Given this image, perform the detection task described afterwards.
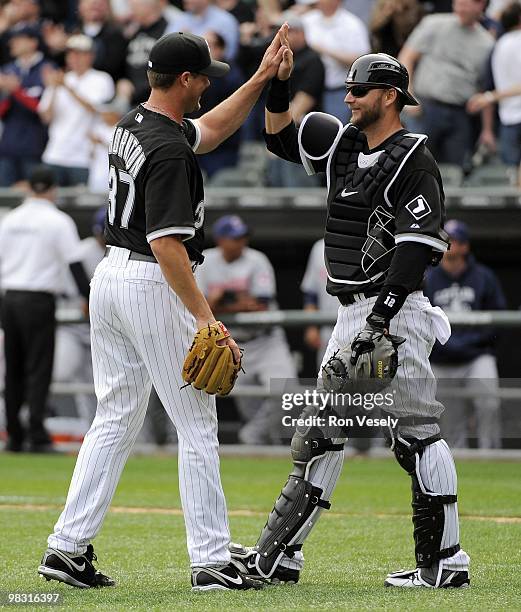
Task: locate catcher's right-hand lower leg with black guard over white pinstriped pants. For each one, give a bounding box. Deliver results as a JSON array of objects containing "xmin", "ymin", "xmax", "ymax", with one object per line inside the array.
[{"xmin": 394, "ymin": 435, "xmax": 468, "ymax": 569}]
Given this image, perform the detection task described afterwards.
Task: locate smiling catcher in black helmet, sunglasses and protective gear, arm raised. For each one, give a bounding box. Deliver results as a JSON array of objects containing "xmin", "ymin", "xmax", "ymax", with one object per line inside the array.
[{"xmin": 233, "ymin": 43, "xmax": 469, "ymax": 588}]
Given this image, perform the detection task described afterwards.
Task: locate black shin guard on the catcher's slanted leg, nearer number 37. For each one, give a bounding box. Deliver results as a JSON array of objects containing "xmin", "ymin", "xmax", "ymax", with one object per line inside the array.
[{"xmin": 254, "ymin": 407, "xmax": 344, "ymax": 578}]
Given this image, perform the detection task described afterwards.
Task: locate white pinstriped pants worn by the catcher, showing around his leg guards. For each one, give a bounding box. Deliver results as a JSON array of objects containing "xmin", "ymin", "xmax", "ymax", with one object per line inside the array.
[{"xmin": 281, "ymin": 291, "xmax": 469, "ymax": 570}]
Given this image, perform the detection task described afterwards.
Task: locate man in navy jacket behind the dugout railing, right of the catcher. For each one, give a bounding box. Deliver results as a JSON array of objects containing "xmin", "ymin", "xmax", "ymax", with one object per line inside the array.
[{"xmin": 424, "ymin": 220, "xmax": 505, "ymax": 448}]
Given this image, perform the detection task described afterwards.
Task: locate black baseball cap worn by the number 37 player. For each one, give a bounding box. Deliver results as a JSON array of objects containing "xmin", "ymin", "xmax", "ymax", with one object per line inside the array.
[{"xmin": 148, "ymin": 32, "xmax": 230, "ymax": 77}]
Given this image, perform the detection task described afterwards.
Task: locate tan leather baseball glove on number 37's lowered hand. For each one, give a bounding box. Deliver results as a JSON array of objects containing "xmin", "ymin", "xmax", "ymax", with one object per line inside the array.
[{"xmin": 183, "ymin": 321, "xmax": 241, "ymax": 395}]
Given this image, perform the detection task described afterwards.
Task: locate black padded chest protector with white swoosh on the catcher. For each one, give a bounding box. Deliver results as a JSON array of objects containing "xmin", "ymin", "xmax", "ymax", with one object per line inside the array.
[{"xmin": 324, "ymin": 125, "xmax": 425, "ymax": 294}]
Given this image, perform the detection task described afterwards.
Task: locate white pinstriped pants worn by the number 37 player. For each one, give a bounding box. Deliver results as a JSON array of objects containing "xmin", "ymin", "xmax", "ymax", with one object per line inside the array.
[{"xmin": 48, "ymin": 247, "xmax": 230, "ymax": 566}]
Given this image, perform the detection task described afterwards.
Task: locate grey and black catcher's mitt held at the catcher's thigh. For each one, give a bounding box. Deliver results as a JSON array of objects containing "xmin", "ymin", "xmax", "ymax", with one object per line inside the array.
[{"xmin": 322, "ymin": 327, "xmax": 405, "ymax": 393}]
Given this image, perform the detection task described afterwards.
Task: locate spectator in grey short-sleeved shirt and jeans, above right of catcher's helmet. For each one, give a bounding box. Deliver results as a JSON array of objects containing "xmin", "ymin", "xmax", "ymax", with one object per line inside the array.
[{"xmin": 398, "ymin": 0, "xmax": 495, "ymax": 166}]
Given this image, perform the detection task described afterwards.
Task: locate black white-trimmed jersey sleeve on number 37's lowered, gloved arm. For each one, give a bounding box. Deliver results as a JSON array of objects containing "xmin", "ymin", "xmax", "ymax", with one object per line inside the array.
[{"xmin": 145, "ymin": 158, "xmax": 195, "ymax": 243}]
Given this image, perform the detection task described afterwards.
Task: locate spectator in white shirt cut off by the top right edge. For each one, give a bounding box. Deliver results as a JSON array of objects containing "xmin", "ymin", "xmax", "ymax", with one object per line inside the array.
[{"xmin": 468, "ymin": 2, "xmax": 521, "ymax": 166}]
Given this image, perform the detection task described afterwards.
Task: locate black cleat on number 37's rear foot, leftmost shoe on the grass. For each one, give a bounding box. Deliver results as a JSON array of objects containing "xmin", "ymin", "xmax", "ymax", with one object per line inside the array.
[{"xmin": 38, "ymin": 544, "xmax": 116, "ymax": 589}]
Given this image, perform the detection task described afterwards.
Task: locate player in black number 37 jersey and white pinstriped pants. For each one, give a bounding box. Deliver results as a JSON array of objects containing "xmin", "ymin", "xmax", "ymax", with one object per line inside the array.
[{"xmin": 38, "ymin": 25, "xmax": 289, "ymax": 591}]
